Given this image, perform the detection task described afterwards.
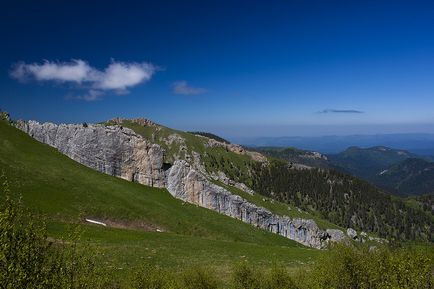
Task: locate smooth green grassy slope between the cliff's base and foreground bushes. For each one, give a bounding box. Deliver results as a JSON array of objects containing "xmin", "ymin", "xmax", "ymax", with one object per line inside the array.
[{"xmin": 0, "ymin": 122, "xmax": 320, "ymax": 282}]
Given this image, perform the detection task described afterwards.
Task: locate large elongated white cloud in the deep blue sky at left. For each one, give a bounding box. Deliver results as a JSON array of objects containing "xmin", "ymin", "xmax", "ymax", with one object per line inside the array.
[{"xmin": 10, "ymin": 59, "xmax": 158, "ymax": 101}]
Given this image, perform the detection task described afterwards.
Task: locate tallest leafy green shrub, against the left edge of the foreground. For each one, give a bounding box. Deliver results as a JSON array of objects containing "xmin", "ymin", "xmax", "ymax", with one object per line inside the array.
[{"xmin": 0, "ymin": 180, "xmax": 59, "ymax": 288}]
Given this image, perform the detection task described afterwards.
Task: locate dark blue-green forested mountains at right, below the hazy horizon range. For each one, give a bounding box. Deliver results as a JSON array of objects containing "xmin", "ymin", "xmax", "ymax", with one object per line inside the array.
[{"xmin": 255, "ymin": 146, "xmax": 434, "ymax": 195}]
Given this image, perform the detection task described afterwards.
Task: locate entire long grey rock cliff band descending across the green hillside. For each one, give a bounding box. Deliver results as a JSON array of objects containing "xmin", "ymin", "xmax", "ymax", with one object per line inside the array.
[{"xmin": 15, "ymin": 121, "xmax": 344, "ymax": 248}]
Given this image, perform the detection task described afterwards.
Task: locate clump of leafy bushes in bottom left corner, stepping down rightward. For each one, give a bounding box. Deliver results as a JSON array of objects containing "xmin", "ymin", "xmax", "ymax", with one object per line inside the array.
[{"xmin": 0, "ymin": 177, "xmax": 108, "ymax": 289}]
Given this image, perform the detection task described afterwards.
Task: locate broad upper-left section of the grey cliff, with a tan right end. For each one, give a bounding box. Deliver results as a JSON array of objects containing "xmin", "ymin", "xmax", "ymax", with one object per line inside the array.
[{"xmin": 15, "ymin": 121, "xmax": 166, "ymax": 188}]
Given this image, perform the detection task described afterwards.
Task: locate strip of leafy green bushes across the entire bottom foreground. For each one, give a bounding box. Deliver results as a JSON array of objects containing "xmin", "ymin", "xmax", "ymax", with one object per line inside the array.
[{"xmin": 0, "ymin": 181, "xmax": 434, "ymax": 289}]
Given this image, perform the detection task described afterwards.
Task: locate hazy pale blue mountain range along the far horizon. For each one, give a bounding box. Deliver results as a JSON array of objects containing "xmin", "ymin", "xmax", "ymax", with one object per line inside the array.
[{"xmin": 231, "ymin": 133, "xmax": 434, "ymax": 156}]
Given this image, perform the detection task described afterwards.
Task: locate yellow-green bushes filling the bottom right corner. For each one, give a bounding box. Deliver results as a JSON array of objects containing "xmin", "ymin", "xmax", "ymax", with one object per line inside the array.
[{"xmin": 299, "ymin": 245, "xmax": 434, "ymax": 289}]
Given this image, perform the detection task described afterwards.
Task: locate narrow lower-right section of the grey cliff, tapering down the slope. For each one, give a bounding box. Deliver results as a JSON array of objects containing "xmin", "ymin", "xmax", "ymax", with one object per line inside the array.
[{"xmin": 167, "ymin": 160, "xmax": 344, "ymax": 248}]
